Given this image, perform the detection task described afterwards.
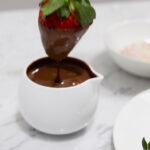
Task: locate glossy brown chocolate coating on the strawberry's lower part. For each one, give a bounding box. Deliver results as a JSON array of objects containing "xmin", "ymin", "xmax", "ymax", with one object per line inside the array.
[{"xmin": 39, "ymin": 21, "xmax": 88, "ymax": 61}]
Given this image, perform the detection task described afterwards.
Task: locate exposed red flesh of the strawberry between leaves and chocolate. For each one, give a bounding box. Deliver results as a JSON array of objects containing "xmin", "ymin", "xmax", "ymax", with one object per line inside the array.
[{"xmin": 39, "ymin": 2, "xmax": 80, "ymax": 29}]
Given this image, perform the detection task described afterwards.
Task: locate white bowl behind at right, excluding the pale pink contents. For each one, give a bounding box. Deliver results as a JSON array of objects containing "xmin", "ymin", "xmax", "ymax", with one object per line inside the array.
[{"xmin": 105, "ymin": 21, "xmax": 150, "ymax": 77}]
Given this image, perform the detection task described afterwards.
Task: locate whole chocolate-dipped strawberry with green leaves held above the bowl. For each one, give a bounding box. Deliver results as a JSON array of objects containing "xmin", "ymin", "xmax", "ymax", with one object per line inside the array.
[{"xmin": 39, "ymin": 0, "xmax": 96, "ymax": 62}]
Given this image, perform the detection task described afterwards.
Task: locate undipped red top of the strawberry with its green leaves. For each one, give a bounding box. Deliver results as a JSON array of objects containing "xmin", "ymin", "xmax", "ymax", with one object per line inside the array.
[{"xmin": 39, "ymin": 0, "xmax": 96, "ymax": 29}]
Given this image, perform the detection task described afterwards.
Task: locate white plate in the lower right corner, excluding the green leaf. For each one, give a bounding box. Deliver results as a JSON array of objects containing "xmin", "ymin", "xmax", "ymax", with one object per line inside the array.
[{"xmin": 113, "ymin": 90, "xmax": 150, "ymax": 150}]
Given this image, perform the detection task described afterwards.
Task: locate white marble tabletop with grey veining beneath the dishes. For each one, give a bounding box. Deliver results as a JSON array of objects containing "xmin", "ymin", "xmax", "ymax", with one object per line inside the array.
[{"xmin": 0, "ymin": 1, "xmax": 150, "ymax": 150}]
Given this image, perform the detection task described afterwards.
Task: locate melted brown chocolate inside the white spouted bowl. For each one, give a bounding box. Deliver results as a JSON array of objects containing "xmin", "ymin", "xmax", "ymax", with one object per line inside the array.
[{"xmin": 27, "ymin": 57, "xmax": 96, "ymax": 88}]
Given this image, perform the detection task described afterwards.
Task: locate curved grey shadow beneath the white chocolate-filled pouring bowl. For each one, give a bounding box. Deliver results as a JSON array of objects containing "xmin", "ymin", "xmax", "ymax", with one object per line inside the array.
[{"xmin": 17, "ymin": 112, "xmax": 87, "ymax": 142}]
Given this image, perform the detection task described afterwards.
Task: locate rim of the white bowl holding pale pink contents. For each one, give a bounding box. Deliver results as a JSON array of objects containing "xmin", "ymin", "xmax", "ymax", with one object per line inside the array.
[{"xmin": 104, "ymin": 19, "xmax": 150, "ymax": 65}]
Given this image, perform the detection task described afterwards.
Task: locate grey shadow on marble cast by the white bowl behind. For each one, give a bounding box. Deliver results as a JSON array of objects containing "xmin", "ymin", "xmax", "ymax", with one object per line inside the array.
[{"xmin": 91, "ymin": 50, "xmax": 150, "ymax": 96}]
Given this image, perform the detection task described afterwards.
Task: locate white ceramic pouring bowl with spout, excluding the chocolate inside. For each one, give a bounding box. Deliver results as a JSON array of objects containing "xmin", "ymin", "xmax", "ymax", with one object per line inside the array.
[{"xmin": 19, "ymin": 57, "xmax": 103, "ymax": 135}]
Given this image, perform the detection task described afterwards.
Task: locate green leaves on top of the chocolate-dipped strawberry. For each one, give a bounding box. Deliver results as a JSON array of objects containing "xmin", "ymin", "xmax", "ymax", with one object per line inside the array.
[{"xmin": 41, "ymin": 0, "xmax": 96, "ymax": 27}]
